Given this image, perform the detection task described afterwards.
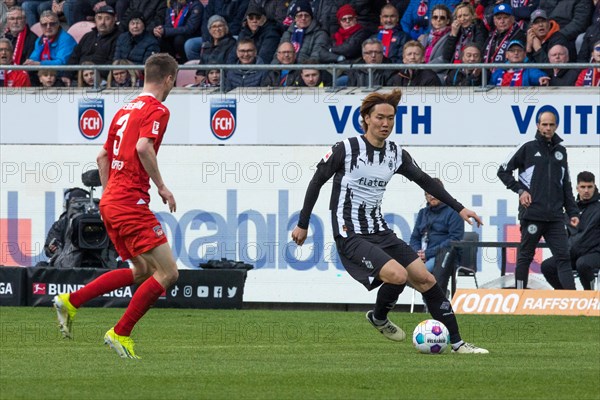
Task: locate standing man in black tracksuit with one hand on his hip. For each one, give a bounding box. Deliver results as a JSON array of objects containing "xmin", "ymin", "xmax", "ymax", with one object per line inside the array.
[{"xmin": 498, "ymin": 111, "xmax": 579, "ymax": 290}]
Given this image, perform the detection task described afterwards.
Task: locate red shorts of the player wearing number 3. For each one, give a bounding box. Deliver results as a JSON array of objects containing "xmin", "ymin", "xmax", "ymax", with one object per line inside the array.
[{"xmin": 100, "ymin": 203, "xmax": 167, "ymax": 260}]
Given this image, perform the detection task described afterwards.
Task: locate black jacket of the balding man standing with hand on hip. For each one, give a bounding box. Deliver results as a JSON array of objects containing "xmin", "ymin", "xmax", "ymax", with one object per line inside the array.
[{"xmin": 498, "ymin": 131, "xmax": 579, "ymax": 221}]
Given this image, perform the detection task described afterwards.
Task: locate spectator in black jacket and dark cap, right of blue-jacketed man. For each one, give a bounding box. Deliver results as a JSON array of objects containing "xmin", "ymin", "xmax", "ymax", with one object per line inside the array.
[{"xmin": 62, "ymin": 6, "xmax": 119, "ymax": 86}]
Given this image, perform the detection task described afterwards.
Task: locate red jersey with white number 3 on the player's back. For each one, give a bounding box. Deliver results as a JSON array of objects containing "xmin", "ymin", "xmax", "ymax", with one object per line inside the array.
[{"xmin": 102, "ymin": 93, "xmax": 171, "ymax": 204}]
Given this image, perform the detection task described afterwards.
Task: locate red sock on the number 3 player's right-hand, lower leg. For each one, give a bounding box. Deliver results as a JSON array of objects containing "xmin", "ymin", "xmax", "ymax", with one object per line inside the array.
[{"xmin": 115, "ymin": 276, "xmax": 165, "ymax": 336}]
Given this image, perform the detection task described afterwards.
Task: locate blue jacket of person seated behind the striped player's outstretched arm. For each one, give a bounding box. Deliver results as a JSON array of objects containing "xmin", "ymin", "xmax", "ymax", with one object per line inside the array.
[{"xmin": 410, "ymin": 203, "xmax": 465, "ymax": 259}]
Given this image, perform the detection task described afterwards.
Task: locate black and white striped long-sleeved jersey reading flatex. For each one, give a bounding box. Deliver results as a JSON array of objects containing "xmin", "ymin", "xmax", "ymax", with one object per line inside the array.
[{"xmin": 298, "ymin": 136, "xmax": 463, "ymax": 237}]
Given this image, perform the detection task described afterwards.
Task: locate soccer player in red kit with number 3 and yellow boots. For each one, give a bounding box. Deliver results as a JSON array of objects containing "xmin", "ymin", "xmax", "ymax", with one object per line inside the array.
[{"xmin": 54, "ymin": 53, "xmax": 178, "ymax": 358}]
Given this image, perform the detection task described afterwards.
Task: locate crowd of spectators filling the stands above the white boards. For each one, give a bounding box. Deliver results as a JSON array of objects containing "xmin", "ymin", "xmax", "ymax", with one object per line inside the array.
[{"xmin": 0, "ymin": 0, "xmax": 600, "ymax": 89}]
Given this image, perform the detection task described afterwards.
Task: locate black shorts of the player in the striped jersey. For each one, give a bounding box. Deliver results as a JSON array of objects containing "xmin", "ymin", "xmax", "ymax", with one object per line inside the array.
[{"xmin": 335, "ymin": 230, "xmax": 419, "ymax": 290}]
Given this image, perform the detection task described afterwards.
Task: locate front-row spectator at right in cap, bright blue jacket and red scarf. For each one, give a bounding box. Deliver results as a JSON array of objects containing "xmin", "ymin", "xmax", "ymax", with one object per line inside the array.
[{"xmin": 491, "ymin": 40, "xmax": 550, "ymax": 86}]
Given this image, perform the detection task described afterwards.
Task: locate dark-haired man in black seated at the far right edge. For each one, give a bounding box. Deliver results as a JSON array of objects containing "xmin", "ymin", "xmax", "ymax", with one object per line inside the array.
[{"xmin": 542, "ymin": 171, "xmax": 600, "ymax": 290}]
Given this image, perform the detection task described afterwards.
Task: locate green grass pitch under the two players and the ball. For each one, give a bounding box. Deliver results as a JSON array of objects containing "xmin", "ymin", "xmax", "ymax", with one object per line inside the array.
[{"xmin": 0, "ymin": 307, "xmax": 600, "ymax": 400}]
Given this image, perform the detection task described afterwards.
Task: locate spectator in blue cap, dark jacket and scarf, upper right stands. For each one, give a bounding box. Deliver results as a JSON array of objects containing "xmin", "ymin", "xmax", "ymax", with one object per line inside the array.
[{"xmin": 482, "ymin": 4, "xmax": 527, "ymax": 63}]
